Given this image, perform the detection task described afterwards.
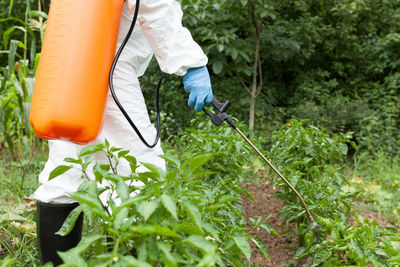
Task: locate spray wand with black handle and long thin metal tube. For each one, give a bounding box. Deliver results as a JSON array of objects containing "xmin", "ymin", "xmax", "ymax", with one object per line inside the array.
[{"xmin": 203, "ymin": 97, "xmax": 314, "ymax": 222}]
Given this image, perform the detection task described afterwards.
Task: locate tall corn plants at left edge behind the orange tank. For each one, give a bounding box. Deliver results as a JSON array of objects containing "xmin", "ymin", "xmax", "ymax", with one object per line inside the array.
[{"xmin": 0, "ymin": 1, "xmax": 46, "ymax": 189}]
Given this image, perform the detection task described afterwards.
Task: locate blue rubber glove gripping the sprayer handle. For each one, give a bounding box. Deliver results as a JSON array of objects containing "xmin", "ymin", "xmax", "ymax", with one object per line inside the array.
[{"xmin": 183, "ymin": 66, "xmax": 213, "ymax": 112}]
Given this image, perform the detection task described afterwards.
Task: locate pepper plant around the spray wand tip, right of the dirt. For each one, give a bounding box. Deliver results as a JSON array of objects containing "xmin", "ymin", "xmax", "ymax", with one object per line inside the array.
[{"xmin": 270, "ymin": 120, "xmax": 354, "ymax": 222}]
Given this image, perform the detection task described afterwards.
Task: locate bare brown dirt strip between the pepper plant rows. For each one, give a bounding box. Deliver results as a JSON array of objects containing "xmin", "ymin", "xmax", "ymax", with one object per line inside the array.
[{"xmin": 242, "ymin": 184, "xmax": 297, "ymax": 267}]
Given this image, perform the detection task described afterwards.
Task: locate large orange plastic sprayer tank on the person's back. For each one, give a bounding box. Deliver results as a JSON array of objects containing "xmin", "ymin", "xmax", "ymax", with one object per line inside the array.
[{"xmin": 30, "ymin": 0, "xmax": 124, "ymax": 144}]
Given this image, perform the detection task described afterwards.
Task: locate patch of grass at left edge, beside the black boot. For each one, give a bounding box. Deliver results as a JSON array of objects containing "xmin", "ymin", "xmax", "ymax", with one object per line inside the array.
[{"xmin": 0, "ymin": 149, "xmax": 47, "ymax": 266}]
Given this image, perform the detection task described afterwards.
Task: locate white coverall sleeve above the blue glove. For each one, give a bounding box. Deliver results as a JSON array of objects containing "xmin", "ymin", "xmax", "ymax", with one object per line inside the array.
[{"xmin": 129, "ymin": 0, "xmax": 208, "ymax": 76}]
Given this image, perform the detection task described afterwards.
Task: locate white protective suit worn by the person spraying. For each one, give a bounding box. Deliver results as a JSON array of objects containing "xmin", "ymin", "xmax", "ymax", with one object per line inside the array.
[{"xmin": 34, "ymin": 0, "xmax": 207, "ymax": 204}]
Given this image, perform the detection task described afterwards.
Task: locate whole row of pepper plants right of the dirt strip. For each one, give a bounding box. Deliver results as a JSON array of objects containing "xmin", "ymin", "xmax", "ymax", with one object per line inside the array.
[{"xmin": 271, "ymin": 120, "xmax": 400, "ymax": 266}]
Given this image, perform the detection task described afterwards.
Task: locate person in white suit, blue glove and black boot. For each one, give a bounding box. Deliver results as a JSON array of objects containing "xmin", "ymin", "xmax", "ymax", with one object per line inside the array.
[{"xmin": 34, "ymin": 0, "xmax": 212, "ymax": 264}]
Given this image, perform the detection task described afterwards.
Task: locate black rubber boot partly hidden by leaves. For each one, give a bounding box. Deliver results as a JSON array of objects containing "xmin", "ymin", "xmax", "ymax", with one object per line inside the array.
[{"xmin": 37, "ymin": 201, "xmax": 83, "ymax": 266}]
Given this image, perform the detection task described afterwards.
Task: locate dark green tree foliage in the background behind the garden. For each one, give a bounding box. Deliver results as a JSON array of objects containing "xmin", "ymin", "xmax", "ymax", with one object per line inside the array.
[{"xmin": 147, "ymin": 0, "xmax": 400, "ymax": 154}]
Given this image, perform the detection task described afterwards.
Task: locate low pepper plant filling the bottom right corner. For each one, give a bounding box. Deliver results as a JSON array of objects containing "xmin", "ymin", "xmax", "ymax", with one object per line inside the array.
[{"xmin": 295, "ymin": 217, "xmax": 400, "ymax": 267}]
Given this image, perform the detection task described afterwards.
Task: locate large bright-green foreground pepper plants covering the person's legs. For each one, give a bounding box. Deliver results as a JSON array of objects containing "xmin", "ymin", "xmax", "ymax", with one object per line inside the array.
[{"xmin": 50, "ymin": 141, "xmax": 268, "ymax": 266}]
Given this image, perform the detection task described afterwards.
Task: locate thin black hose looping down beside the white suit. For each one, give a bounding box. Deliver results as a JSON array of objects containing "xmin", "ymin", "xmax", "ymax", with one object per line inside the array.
[{"xmin": 108, "ymin": 0, "xmax": 166, "ymax": 148}]
